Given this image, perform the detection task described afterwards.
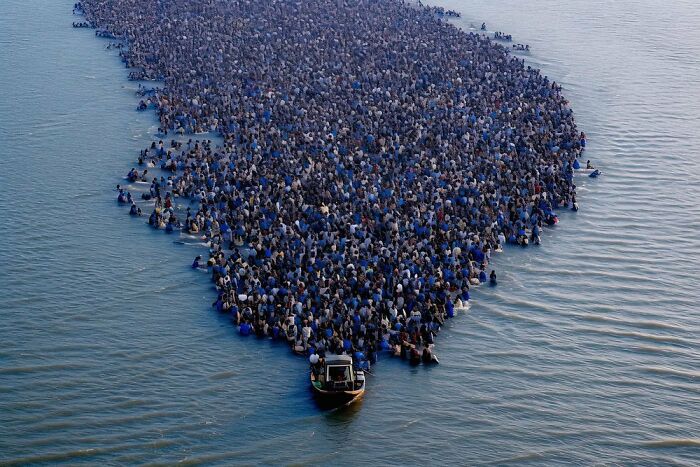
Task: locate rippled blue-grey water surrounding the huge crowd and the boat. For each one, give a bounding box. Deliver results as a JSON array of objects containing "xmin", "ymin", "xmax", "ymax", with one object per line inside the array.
[{"xmin": 0, "ymin": 0, "xmax": 700, "ymax": 465}]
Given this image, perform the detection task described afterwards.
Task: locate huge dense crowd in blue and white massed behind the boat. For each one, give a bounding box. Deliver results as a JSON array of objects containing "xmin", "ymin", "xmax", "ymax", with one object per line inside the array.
[{"xmin": 79, "ymin": 0, "xmax": 585, "ymax": 368}]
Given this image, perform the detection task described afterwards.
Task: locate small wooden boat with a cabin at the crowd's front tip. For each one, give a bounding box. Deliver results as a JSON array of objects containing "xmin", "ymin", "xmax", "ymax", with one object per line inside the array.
[{"xmin": 310, "ymin": 355, "xmax": 365, "ymax": 407}]
